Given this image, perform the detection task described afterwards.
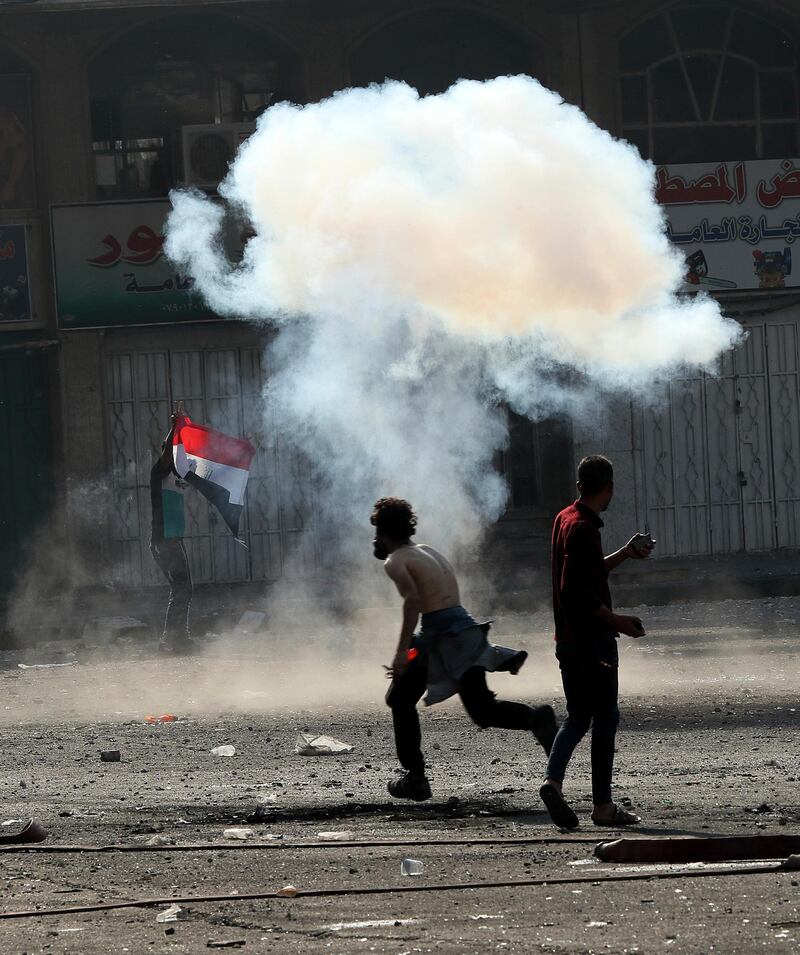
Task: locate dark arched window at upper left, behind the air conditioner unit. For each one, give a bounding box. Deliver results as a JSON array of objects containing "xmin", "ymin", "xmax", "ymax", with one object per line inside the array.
[{"xmin": 89, "ymin": 14, "xmax": 296, "ymax": 199}]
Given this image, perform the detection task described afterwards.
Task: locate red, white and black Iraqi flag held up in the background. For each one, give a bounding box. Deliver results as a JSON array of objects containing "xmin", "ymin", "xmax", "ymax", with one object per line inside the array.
[{"xmin": 172, "ymin": 415, "xmax": 256, "ymax": 540}]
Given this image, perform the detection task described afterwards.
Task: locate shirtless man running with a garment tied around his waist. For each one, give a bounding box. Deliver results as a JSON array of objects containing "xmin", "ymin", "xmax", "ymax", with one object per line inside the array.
[{"xmin": 370, "ymin": 497, "xmax": 557, "ymax": 802}]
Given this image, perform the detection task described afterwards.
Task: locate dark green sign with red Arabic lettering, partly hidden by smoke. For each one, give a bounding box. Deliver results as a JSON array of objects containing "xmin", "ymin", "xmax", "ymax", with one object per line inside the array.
[{"xmin": 52, "ymin": 200, "xmax": 217, "ymax": 328}]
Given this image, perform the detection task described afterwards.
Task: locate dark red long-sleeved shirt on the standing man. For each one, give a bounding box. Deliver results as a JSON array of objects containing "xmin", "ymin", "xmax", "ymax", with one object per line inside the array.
[{"xmin": 552, "ymin": 501, "xmax": 618, "ymax": 641}]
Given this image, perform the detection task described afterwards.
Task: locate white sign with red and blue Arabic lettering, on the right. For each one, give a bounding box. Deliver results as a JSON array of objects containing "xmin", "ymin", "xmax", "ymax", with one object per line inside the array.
[{"xmin": 656, "ymin": 159, "xmax": 800, "ymax": 291}]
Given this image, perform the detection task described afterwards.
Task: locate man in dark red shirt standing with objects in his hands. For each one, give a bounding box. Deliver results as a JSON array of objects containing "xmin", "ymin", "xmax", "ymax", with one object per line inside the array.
[{"xmin": 539, "ymin": 455, "xmax": 655, "ymax": 829}]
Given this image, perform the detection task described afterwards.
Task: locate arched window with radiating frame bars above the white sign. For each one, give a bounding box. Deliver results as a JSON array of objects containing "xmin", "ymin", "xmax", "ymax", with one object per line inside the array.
[{"xmin": 619, "ymin": 3, "xmax": 798, "ymax": 163}]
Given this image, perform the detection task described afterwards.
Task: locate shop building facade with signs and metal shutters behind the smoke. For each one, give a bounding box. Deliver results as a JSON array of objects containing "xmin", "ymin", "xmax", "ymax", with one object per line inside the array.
[{"xmin": 0, "ymin": 0, "xmax": 800, "ymax": 589}]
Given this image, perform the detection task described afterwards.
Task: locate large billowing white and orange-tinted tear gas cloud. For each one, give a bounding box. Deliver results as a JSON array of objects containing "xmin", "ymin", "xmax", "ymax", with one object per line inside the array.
[{"xmin": 166, "ymin": 77, "xmax": 739, "ymax": 542}]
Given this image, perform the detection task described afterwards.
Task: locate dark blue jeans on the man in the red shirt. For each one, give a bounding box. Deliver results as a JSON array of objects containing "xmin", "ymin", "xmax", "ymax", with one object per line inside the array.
[{"xmin": 547, "ymin": 637, "xmax": 619, "ymax": 806}]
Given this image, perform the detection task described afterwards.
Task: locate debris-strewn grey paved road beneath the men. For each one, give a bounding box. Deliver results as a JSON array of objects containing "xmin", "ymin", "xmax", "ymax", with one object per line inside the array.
[{"xmin": 0, "ymin": 598, "xmax": 800, "ymax": 955}]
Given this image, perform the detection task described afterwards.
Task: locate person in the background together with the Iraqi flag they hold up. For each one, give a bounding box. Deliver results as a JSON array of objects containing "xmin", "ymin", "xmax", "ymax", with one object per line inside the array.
[{"xmin": 150, "ymin": 402, "xmax": 255, "ymax": 654}]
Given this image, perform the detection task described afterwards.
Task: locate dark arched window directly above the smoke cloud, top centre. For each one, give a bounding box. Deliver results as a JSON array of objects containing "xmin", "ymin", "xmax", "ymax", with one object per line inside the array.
[{"xmin": 350, "ymin": 8, "xmax": 534, "ymax": 96}]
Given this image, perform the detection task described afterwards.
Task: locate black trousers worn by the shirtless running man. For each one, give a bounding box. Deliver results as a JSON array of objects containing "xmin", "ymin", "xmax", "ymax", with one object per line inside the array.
[{"xmin": 386, "ymin": 655, "xmax": 536, "ymax": 776}]
